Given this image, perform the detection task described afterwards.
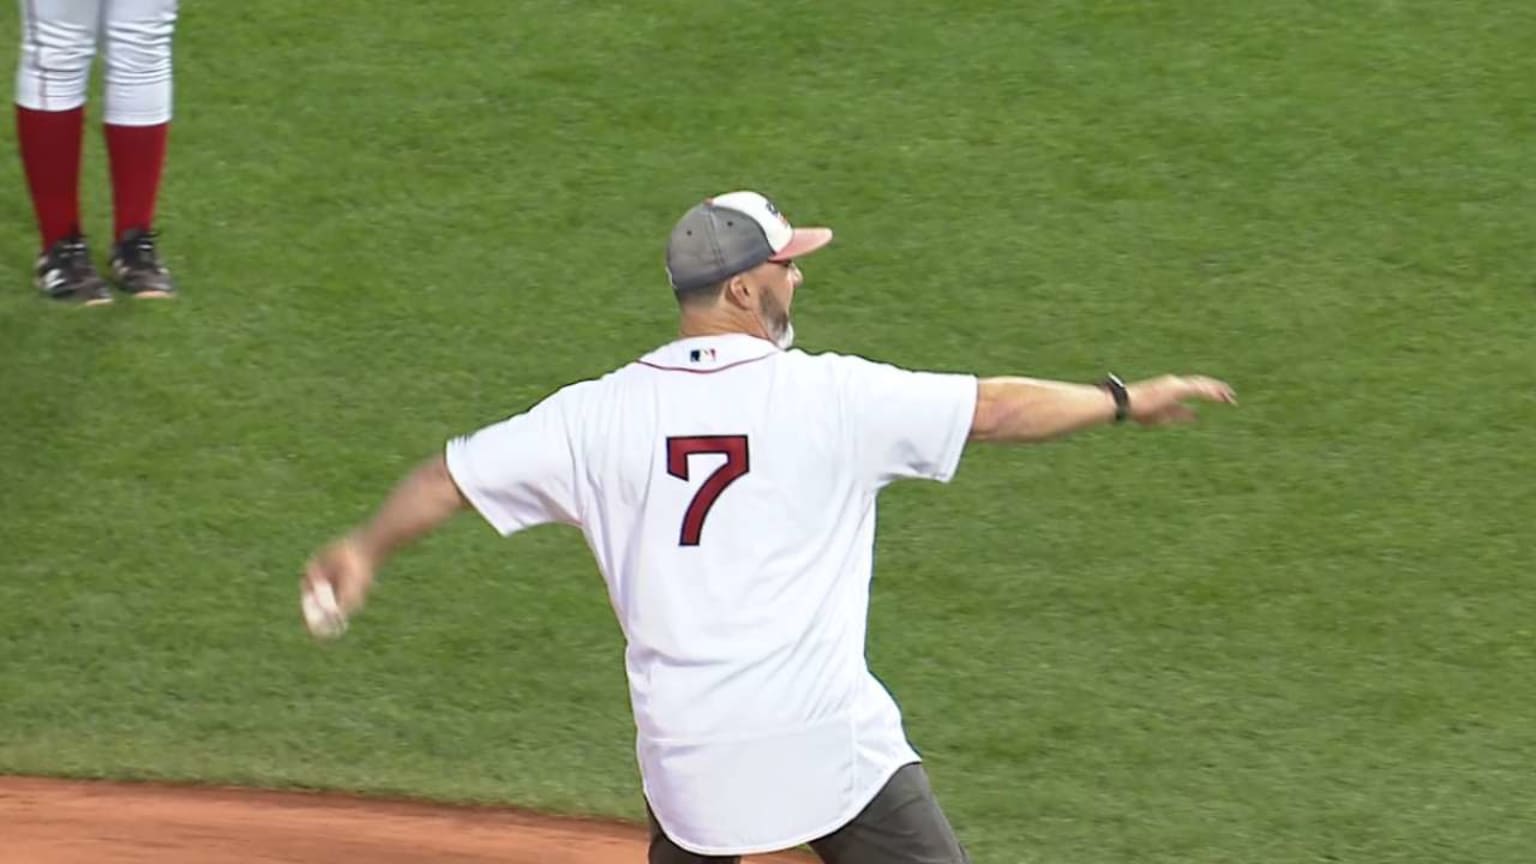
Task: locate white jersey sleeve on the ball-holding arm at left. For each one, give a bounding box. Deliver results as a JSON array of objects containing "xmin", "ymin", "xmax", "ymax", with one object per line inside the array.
[{"xmin": 445, "ymin": 382, "xmax": 581, "ymax": 537}]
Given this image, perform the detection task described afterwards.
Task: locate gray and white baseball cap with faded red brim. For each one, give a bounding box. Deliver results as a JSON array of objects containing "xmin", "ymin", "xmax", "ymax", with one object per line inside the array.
[{"xmin": 667, "ymin": 192, "xmax": 833, "ymax": 291}]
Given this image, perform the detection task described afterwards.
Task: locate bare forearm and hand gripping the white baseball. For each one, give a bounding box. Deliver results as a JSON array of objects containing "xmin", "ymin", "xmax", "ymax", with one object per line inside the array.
[{"xmin": 304, "ymin": 455, "xmax": 465, "ymax": 615}]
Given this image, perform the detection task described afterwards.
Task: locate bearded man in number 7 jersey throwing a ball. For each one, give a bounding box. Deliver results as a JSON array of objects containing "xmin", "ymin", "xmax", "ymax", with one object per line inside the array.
[{"xmin": 304, "ymin": 192, "xmax": 1235, "ymax": 864}]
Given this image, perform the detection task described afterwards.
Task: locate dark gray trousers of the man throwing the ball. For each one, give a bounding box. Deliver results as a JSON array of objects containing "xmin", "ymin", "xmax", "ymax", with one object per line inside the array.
[{"xmin": 647, "ymin": 763, "xmax": 971, "ymax": 864}]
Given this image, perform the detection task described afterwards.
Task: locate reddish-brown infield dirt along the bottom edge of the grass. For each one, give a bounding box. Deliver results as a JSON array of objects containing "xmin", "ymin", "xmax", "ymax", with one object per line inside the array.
[{"xmin": 0, "ymin": 778, "xmax": 811, "ymax": 864}]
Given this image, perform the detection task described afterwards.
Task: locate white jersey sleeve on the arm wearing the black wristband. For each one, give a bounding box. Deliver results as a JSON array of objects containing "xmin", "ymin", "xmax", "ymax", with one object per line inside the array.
[{"xmin": 845, "ymin": 358, "xmax": 977, "ymax": 487}]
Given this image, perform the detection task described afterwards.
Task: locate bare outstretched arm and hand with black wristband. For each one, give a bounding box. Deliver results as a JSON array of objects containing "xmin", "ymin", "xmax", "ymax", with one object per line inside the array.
[{"xmin": 971, "ymin": 375, "xmax": 1236, "ymax": 444}]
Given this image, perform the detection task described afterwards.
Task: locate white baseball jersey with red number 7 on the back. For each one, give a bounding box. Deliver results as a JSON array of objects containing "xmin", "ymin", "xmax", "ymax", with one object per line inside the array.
[{"xmin": 447, "ymin": 335, "xmax": 977, "ymax": 855}]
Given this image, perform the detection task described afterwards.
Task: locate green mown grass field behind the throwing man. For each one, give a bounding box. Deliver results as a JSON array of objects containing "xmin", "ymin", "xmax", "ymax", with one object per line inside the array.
[{"xmin": 0, "ymin": 0, "xmax": 1536, "ymax": 864}]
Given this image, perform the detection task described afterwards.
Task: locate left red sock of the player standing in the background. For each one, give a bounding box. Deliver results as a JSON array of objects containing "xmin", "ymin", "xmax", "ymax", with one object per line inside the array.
[{"xmin": 15, "ymin": 105, "xmax": 86, "ymax": 251}]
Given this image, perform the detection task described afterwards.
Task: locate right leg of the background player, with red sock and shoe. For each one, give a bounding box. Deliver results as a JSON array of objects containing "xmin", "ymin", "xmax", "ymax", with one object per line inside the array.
[{"xmin": 101, "ymin": 0, "xmax": 178, "ymax": 298}]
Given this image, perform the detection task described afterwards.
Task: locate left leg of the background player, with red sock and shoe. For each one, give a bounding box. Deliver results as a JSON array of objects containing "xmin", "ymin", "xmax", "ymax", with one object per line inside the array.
[{"xmin": 15, "ymin": 0, "xmax": 112, "ymax": 306}]
